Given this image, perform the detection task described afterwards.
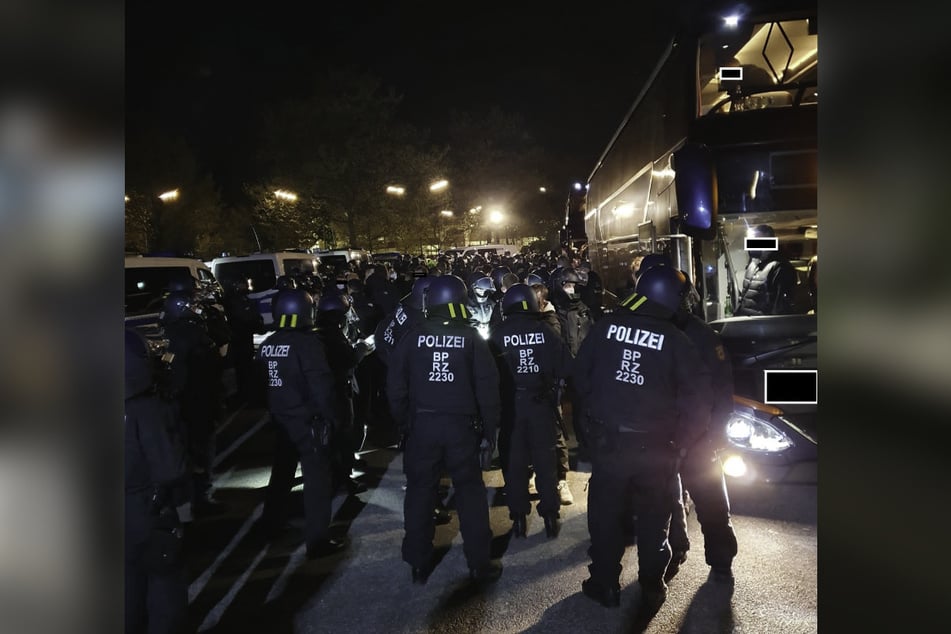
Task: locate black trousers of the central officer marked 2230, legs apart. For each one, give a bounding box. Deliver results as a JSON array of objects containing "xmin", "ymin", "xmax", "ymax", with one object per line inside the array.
[{"xmin": 402, "ymin": 414, "xmax": 492, "ymax": 568}]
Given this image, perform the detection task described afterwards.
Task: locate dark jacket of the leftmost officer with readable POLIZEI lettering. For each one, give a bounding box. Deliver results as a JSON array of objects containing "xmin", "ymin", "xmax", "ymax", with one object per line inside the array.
[{"xmin": 258, "ymin": 328, "xmax": 336, "ymax": 444}]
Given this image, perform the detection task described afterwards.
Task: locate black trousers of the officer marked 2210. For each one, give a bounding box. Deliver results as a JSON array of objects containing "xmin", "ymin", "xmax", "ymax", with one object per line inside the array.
[{"xmin": 502, "ymin": 391, "xmax": 561, "ymax": 519}]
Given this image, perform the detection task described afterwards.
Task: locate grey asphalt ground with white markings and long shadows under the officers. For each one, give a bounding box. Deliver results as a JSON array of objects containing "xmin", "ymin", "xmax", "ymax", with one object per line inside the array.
[{"xmin": 180, "ymin": 400, "xmax": 817, "ymax": 634}]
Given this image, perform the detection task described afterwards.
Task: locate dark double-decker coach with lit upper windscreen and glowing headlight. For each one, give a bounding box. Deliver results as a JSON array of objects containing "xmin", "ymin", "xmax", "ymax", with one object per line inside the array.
[{"xmin": 563, "ymin": 0, "xmax": 819, "ymax": 481}]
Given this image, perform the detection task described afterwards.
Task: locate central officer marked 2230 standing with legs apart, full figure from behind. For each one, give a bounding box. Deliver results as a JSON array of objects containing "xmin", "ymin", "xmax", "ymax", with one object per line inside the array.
[{"xmin": 387, "ymin": 275, "xmax": 501, "ymax": 583}]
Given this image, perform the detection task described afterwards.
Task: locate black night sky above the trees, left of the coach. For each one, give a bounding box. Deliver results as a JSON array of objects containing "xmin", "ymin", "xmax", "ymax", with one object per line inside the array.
[{"xmin": 126, "ymin": 0, "xmax": 669, "ymax": 200}]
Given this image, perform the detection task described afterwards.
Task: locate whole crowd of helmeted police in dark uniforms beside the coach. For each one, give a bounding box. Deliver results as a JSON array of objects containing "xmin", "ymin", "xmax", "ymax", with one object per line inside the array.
[{"xmin": 126, "ymin": 248, "xmax": 737, "ymax": 631}]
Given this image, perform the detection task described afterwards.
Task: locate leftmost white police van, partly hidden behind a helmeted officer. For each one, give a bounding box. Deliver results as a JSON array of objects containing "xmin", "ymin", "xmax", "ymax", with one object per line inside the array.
[{"xmin": 125, "ymin": 255, "xmax": 222, "ymax": 336}]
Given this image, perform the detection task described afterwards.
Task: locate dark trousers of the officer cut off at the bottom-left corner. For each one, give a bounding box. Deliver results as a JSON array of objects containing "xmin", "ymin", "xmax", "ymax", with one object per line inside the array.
[{"xmin": 125, "ymin": 492, "xmax": 188, "ymax": 634}]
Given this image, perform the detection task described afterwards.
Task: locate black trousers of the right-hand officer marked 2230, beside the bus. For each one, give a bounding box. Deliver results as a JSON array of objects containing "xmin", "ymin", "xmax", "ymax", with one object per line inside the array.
[{"xmin": 588, "ymin": 433, "xmax": 676, "ymax": 591}]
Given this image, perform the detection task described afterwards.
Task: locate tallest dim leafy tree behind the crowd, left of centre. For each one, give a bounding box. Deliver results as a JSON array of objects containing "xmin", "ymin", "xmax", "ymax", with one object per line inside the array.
[{"xmin": 261, "ymin": 70, "xmax": 438, "ymax": 249}]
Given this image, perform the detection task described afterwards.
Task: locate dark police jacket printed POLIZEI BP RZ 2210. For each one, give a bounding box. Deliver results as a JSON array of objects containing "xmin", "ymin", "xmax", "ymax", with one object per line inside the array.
[{"xmin": 489, "ymin": 312, "xmax": 571, "ymax": 404}]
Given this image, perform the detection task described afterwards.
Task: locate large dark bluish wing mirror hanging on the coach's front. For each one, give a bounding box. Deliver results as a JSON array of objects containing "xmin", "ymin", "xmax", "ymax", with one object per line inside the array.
[{"xmin": 673, "ymin": 143, "xmax": 717, "ymax": 240}]
